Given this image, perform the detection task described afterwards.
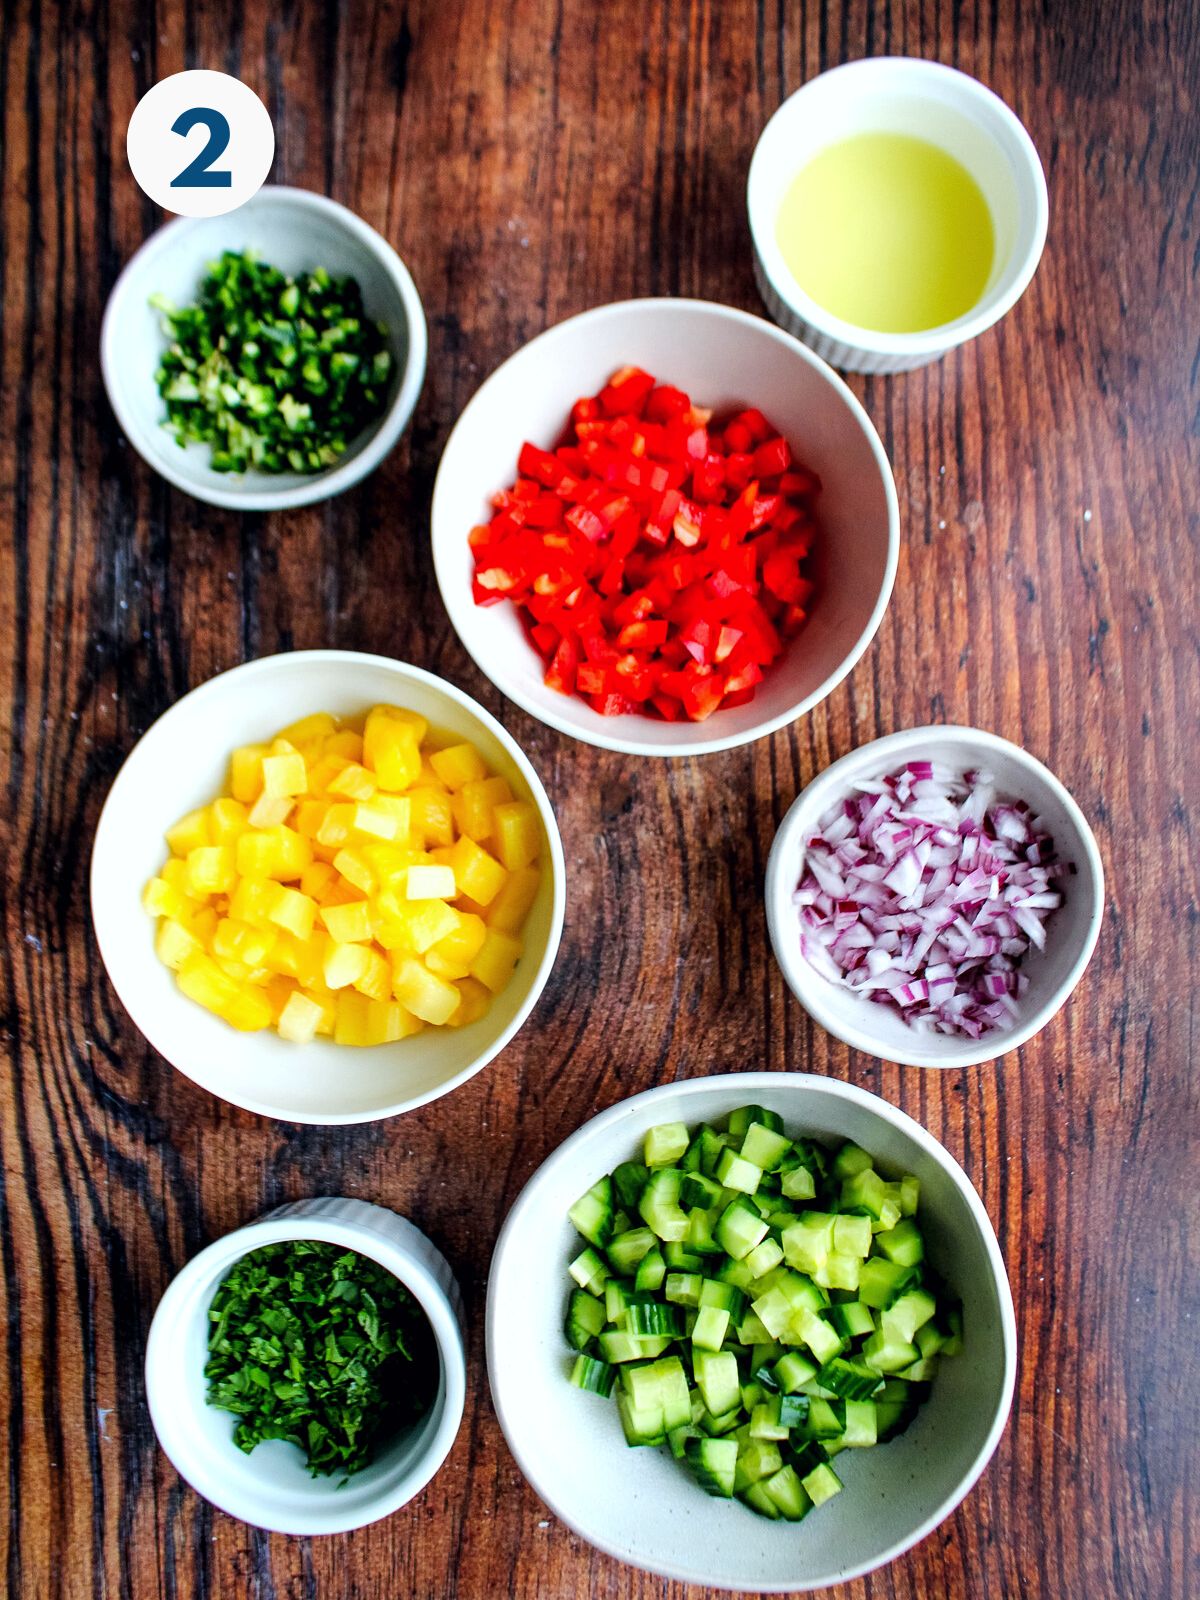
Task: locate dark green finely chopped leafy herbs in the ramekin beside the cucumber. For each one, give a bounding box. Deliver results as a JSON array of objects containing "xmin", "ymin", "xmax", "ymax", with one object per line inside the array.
[{"xmin": 205, "ymin": 1238, "xmax": 437, "ymax": 1477}]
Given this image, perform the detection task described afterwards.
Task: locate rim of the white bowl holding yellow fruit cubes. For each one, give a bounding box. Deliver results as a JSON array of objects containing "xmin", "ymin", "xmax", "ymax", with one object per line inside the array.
[{"xmin": 88, "ymin": 650, "xmax": 566, "ymax": 1126}]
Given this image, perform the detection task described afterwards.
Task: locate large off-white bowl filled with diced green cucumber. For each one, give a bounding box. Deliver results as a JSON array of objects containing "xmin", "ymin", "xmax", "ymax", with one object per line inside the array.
[{"xmin": 486, "ymin": 1072, "xmax": 1016, "ymax": 1592}]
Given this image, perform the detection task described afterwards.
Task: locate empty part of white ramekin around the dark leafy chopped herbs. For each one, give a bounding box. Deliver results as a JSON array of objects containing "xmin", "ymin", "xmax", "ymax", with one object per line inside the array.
[{"xmin": 146, "ymin": 1198, "xmax": 466, "ymax": 1534}]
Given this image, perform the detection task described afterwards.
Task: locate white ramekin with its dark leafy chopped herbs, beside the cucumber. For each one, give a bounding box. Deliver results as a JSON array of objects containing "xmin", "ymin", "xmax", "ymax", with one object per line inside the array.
[{"xmin": 146, "ymin": 1198, "xmax": 466, "ymax": 1534}]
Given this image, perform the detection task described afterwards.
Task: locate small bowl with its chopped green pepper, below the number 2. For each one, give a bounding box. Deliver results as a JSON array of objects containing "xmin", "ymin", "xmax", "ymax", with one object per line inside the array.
[{"xmin": 101, "ymin": 186, "xmax": 427, "ymax": 510}]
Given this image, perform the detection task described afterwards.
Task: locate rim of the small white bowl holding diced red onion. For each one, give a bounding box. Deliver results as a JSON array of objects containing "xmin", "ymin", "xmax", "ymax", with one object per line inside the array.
[{"xmin": 763, "ymin": 723, "xmax": 1104, "ymax": 1070}]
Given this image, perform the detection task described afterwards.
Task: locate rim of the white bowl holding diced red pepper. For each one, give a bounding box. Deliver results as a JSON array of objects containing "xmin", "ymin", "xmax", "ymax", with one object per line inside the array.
[{"xmin": 429, "ymin": 294, "xmax": 899, "ymax": 760}]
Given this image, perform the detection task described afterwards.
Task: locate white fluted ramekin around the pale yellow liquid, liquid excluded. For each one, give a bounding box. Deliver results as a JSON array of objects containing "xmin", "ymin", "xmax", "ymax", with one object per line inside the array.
[{"xmin": 746, "ymin": 56, "xmax": 1050, "ymax": 373}]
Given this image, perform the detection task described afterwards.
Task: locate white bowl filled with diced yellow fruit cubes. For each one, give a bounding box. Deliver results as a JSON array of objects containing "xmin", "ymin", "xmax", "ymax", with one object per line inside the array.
[{"xmin": 91, "ymin": 650, "xmax": 565, "ymax": 1123}]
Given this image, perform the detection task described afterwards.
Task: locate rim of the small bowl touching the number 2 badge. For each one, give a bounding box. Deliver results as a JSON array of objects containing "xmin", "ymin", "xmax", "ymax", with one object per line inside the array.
[{"xmin": 99, "ymin": 184, "xmax": 429, "ymax": 512}]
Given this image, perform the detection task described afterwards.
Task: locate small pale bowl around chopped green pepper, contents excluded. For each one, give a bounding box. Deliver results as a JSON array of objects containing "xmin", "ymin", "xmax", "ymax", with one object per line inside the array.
[{"xmin": 101, "ymin": 184, "xmax": 427, "ymax": 510}]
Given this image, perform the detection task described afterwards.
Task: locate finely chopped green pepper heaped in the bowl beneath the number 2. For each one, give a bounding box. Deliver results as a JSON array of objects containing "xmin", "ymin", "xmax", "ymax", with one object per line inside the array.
[{"xmin": 150, "ymin": 250, "xmax": 392, "ymax": 472}]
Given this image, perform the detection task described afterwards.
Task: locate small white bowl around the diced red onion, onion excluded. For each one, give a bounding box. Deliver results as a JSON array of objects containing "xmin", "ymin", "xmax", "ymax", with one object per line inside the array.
[{"xmin": 766, "ymin": 726, "xmax": 1104, "ymax": 1067}]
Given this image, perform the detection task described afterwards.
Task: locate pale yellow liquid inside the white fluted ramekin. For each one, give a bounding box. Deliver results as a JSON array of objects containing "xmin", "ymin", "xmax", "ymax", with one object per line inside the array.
[{"xmin": 778, "ymin": 133, "xmax": 995, "ymax": 333}]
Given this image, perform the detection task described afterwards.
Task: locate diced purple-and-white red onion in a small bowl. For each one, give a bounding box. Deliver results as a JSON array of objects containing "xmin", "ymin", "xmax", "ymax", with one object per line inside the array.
[{"xmin": 794, "ymin": 762, "xmax": 1070, "ymax": 1038}]
